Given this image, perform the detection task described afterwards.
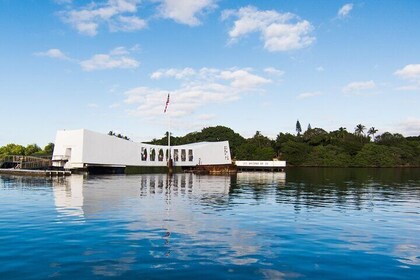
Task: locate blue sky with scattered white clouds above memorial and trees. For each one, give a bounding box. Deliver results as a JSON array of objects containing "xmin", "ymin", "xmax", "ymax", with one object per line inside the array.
[{"xmin": 0, "ymin": 0, "xmax": 420, "ymax": 145}]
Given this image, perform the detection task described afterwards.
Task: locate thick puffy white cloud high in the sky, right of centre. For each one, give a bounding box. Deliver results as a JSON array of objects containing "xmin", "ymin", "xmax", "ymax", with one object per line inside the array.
[{"xmin": 222, "ymin": 6, "xmax": 315, "ymax": 52}]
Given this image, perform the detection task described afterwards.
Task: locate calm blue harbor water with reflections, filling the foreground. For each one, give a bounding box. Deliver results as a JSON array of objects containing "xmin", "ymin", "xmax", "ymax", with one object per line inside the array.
[{"xmin": 0, "ymin": 169, "xmax": 420, "ymax": 279}]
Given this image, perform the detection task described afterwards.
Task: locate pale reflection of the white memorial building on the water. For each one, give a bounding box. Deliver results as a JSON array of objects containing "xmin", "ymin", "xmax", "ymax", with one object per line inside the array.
[{"xmin": 53, "ymin": 173, "xmax": 235, "ymax": 218}]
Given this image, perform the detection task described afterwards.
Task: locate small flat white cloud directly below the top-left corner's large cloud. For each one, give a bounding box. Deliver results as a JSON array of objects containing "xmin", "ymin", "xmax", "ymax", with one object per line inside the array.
[{"xmin": 80, "ymin": 47, "xmax": 140, "ymax": 71}]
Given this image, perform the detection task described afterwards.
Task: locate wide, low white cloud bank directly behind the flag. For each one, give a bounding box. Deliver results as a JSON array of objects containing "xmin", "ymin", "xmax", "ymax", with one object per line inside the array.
[{"xmin": 124, "ymin": 68, "xmax": 271, "ymax": 120}]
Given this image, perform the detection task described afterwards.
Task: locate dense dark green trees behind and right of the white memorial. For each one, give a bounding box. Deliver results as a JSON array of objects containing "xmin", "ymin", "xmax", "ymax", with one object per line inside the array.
[{"xmin": 150, "ymin": 121, "xmax": 420, "ymax": 167}]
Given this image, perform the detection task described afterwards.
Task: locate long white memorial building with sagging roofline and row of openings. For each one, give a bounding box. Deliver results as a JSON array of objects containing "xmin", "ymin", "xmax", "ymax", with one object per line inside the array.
[{"xmin": 52, "ymin": 129, "xmax": 232, "ymax": 169}]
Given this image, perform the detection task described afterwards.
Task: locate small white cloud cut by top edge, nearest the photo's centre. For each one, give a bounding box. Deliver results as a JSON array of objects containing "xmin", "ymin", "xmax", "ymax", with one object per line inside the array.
[{"xmin": 158, "ymin": 0, "xmax": 216, "ymax": 26}]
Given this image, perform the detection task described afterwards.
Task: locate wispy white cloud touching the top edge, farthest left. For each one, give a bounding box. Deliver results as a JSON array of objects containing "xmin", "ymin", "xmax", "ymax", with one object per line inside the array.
[{"xmin": 61, "ymin": 0, "xmax": 146, "ymax": 36}]
